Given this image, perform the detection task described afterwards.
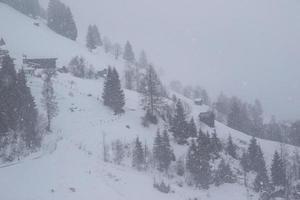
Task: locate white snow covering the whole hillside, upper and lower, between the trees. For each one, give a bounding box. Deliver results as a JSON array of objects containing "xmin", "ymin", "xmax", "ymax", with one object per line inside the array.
[{"xmin": 0, "ymin": 3, "xmax": 293, "ymax": 200}]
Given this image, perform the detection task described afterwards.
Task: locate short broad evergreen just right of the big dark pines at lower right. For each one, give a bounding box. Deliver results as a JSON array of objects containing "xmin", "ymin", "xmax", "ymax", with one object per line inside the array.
[{"xmin": 214, "ymin": 159, "xmax": 235, "ymax": 186}]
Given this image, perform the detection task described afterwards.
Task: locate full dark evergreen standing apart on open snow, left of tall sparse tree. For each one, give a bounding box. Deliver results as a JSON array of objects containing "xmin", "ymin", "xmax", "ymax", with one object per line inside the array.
[{"xmin": 102, "ymin": 67, "xmax": 125, "ymax": 114}]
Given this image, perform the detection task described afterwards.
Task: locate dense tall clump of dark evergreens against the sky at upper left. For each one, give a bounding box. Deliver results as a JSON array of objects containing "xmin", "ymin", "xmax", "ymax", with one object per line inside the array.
[{"xmin": 47, "ymin": 0, "xmax": 77, "ymax": 40}]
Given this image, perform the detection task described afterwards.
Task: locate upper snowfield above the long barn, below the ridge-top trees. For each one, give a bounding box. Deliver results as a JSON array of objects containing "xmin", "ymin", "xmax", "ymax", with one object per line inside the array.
[{"xmin": 0, "ymin": 3, "xmax": 120, "ymax": 69}]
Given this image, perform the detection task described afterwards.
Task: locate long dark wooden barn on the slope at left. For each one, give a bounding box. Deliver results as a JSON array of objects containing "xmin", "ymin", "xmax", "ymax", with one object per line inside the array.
[{"xmin": 23, "ymin": 58, "xmax": 57, "ymax": 69}]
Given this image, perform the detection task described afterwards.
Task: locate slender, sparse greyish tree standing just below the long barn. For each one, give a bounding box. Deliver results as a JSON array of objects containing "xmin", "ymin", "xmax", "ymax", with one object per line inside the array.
[{"xmin": 42, "ymin": 71, "xmax": 58, "ymax": 131}]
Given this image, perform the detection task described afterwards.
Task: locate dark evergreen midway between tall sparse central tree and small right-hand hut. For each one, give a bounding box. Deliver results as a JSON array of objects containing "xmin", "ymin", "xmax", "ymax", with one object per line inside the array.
[{"xmin": 171, "ymin": 100, "xmax": 189, "ymax": 144}]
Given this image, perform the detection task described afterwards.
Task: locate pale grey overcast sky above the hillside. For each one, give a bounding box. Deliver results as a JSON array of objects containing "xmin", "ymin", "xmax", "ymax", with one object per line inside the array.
[{"xmin": 41, "ymin": 0, "xmax": 300, "ymax": 119}]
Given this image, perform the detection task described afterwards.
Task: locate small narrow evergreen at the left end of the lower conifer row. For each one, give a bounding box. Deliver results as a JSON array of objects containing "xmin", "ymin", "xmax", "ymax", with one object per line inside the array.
[{"xmin": 132, "ymin": 138, "xmax": 145, "ymax": 170}]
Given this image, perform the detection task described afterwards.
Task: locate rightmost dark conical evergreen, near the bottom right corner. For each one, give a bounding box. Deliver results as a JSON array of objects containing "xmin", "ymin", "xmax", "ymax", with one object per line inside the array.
[{"xmin": 271, "ymin": 151, "xmax": 286, "ymax": 186}]
